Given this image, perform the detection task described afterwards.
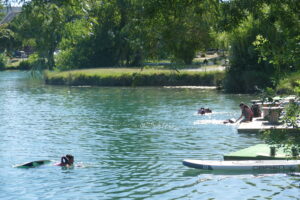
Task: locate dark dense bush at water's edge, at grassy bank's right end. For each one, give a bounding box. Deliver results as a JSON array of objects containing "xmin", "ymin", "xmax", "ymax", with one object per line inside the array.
[{"xmin": 224, "ymin": 17, "xmax": 275, "ymax": 93}]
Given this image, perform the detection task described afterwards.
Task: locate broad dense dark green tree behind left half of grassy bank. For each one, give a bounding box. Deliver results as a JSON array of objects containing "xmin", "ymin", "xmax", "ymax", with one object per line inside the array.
[{"xmin": 59, "ymin": 0, "xmax": 148, "ymax": 68}]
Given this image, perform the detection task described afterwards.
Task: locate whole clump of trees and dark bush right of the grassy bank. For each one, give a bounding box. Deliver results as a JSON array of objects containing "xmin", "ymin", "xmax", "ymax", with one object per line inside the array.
[{"xmin": 219, "ymin": 0, "xmax": 300, "ymax": 92}]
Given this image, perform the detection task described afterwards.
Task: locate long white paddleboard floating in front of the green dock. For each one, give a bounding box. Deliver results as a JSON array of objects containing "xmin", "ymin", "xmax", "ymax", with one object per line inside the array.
[{"xmin": 182, "ymin": 160, "xmax": 300, "ymax": 171}]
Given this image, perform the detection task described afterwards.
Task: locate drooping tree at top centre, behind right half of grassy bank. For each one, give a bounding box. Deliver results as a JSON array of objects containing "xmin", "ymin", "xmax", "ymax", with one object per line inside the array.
[{"xmin": 145, "ymin": 0, "xmax": 218, "ymax": 64}]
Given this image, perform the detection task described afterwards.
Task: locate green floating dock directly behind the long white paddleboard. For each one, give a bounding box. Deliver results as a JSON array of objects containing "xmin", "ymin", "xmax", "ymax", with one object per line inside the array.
[{"xmin": 224, "ymin": 144, "xmax": 299, "ymax": 160}]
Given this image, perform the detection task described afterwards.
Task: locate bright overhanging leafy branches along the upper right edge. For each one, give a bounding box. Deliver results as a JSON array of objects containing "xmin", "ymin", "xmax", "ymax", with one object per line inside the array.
[{"xmin": 255, "ymin": 0, "xmax": 300, "ymax": 74}]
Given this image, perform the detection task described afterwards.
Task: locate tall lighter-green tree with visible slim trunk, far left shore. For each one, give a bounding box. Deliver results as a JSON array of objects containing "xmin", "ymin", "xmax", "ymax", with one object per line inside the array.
[{"xmin": 16, "ymin": 0, "xmax": 84, "ymax": 69}]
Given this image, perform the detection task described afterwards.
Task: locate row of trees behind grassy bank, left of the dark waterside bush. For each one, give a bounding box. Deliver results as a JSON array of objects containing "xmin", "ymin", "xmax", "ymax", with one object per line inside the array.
[{"xmin": 5, "ymin": 0, "xmax": 218, "ymax": 68}]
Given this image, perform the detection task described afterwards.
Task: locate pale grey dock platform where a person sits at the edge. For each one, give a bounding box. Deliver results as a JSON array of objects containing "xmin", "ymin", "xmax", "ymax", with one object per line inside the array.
[{"xmin": 237, "ymin": 117, "xmax": 299, "ymax": 133}]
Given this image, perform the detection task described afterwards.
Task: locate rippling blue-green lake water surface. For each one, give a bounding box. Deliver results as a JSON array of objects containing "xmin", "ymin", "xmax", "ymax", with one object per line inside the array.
[{"xmin": 0, "ymin": 72, "xmax": 300, "ymax": 200}]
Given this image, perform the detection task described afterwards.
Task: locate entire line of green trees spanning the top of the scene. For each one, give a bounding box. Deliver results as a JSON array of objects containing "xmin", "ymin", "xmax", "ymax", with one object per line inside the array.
[{"xmin": 0, "ymin": 0, "xmax": 300, "ymax": 92}]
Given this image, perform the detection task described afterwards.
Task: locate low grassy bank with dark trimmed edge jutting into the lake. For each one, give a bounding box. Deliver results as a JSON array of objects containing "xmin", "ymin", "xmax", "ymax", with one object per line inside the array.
[{"xmin": 45, "ymin": 68, "xmax": 225, "ymax": 86}]
